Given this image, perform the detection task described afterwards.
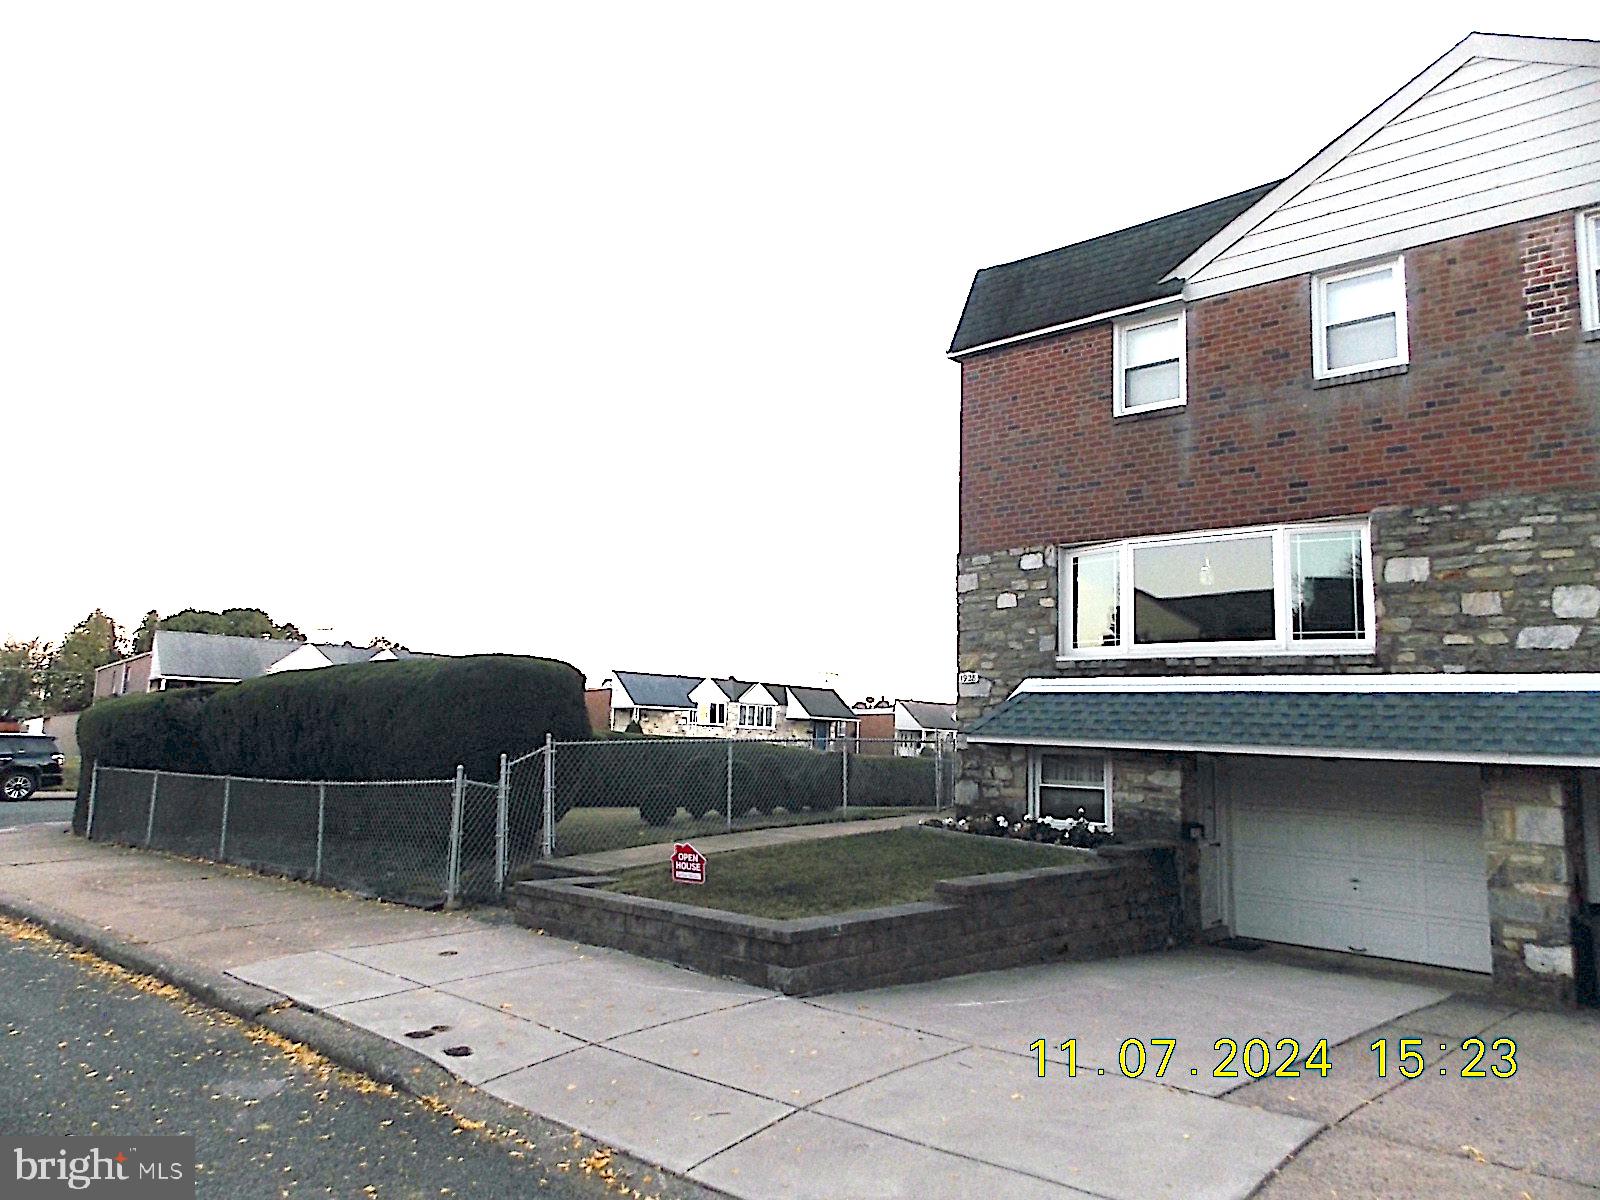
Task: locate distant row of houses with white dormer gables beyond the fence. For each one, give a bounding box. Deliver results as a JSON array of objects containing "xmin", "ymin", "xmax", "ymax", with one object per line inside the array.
[{"xmin": 602, "ymin": 670, "xmax": 859, "ymax": 747}]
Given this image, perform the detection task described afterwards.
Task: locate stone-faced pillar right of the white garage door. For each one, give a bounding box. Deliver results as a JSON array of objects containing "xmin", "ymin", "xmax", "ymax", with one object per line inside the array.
[{"xmin": 1483, "ymin": 766, "xmax": 1584, "ymax": 1003}]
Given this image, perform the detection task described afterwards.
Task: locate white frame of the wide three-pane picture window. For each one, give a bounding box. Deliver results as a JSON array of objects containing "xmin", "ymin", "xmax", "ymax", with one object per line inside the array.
[{"xmin": 1056, "ymin": 520, "xmax": 1378, "ymax": 662}]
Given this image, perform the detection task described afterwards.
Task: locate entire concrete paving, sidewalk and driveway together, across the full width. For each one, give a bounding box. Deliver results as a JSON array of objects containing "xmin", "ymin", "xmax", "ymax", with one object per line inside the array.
[{"xmin": 0, "ymin": 827, "xmax": 1600, "ymax": 1200}]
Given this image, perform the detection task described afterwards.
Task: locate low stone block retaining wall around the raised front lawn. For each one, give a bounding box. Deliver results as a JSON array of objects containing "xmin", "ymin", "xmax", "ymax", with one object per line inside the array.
[{"xmin": 512, "ymin": 829, "xmax": 1184, "ymax": 995}]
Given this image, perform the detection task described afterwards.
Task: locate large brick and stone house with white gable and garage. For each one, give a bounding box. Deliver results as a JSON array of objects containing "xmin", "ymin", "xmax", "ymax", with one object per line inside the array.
[{"xmin": 950, "ymin": 34, "xmax": 1600, "ymax": 1000}]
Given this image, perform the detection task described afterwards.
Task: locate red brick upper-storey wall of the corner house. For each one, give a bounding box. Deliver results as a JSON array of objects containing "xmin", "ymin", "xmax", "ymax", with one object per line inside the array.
[{"xmin": 962, "ymin": 214, "xmax": 1600, "ymax": 555}]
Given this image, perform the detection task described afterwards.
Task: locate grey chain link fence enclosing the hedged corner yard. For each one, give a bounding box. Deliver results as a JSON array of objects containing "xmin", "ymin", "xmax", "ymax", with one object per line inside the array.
[{"xmin": 88, "ymin": 738, "xmax": 955, "ymax": 906}]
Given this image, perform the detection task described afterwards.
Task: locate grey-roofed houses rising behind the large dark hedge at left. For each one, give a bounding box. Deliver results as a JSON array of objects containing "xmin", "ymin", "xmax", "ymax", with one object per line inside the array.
[{"xmin": 94, "ymin": 629, "xmax": 419, "ymax": 699}]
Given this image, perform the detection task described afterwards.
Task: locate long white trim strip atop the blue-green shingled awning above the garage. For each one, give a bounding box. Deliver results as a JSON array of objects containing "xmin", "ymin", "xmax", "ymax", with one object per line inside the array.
[{"xmin": 1011, "ymin": 670, "xmax": 1600, "ymax": 696}]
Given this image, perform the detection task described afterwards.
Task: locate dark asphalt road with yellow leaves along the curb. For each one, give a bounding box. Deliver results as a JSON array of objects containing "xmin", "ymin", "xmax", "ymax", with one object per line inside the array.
[{"xmin": 0, "ymin": 917, "xmax": 677, "ymax": 1198}]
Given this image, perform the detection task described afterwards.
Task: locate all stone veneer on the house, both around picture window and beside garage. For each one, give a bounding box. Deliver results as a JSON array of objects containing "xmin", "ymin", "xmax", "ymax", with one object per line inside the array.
[{"xmin": 955, "ymin": 491, "xmax": 1600, "ymax": 1002}]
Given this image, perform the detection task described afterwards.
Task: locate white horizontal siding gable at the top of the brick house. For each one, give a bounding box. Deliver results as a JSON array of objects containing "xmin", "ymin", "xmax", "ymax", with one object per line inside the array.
[{"xmin": 1181, "ymin": 52, "xmax": 1600, "ymax": 298}]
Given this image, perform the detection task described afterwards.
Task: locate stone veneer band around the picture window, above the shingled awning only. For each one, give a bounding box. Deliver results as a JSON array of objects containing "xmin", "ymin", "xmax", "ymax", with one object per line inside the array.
[{"xmin": 955, "ymin": 491, "xmax": 1600, "ymax": 725}]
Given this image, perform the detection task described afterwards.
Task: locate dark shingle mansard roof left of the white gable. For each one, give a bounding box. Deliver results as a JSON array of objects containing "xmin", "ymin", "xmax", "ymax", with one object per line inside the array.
[{"xmin": 950, "ymin": 181, "xmax": 1277, "ymax": 354}]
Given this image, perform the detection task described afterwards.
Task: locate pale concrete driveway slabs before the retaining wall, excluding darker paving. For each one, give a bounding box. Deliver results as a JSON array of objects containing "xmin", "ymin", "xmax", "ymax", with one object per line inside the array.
[{"xmin": 232, "ymin": 928, "xmax": 1478, "ymax": 1200}]
